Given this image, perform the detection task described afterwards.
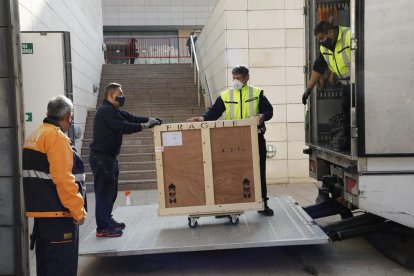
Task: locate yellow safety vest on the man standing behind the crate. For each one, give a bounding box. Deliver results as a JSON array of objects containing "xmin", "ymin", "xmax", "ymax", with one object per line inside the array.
[{"xmin": 220, "ymin": 85, "xmax": 262, "ymax": 120}]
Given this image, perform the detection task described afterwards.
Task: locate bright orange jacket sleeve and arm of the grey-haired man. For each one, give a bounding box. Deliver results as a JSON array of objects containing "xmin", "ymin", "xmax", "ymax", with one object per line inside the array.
[{"xmin": 46, "ymin": 135, "xmax": 86, "ymax": 223}]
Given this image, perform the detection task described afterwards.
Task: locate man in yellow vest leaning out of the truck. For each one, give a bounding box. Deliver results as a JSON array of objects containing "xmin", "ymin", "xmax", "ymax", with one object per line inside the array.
[{"xmin": 302, "ymin": 21, "xmax": 351, "ymax": 150}]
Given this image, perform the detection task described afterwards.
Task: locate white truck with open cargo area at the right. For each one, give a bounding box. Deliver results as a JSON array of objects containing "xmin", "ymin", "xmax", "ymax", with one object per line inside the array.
[{"xmin": 304, "ymin": 0, "xmax": 414, "ymax": 247}]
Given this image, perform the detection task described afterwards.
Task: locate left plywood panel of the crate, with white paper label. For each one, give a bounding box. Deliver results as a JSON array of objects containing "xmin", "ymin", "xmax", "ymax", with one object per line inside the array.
[{"xmin": 161, "ymin": 129, "xmax": 206, "ymax": 208}]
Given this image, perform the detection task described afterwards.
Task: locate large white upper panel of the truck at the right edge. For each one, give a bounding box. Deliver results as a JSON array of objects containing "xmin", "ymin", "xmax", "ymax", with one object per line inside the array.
[{"xmin": 356, "ymin": 0, "xmax": 414, "ymax": 156}]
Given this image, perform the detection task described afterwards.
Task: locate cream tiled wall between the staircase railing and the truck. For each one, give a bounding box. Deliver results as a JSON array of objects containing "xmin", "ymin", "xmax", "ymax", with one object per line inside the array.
[{"xmin": 197, "ymin": 0, "xmax": 309, "ymax": 183}]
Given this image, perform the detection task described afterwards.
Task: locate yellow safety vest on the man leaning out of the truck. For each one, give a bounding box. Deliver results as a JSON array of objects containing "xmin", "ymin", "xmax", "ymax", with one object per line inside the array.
[{"xmin": 320, "ymin": 26, "xmax": 351, "ymax": 79}]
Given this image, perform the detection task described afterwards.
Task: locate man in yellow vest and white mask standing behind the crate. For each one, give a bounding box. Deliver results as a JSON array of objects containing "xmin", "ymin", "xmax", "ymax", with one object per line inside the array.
[{"xmin": 188, "ymin": 66, "xmax": 273, "ymax": 216}]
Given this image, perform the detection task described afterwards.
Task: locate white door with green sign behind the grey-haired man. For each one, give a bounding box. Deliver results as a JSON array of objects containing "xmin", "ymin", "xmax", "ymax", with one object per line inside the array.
[{"xmin": 21, "ymin": 32, "xmax": 73, "ymax": 139}]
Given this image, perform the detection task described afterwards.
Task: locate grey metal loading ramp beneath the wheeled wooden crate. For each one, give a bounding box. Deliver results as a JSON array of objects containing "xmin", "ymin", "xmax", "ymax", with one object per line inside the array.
[{"xmin": 79, "ymin": 196, "xmax": 329, "ymax": 256}]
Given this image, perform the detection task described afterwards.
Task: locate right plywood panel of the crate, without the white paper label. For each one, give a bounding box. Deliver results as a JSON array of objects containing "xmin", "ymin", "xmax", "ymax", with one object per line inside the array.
[{"xmin": 210, "ymin": 126, "xmax": 255, "ymax": 204}]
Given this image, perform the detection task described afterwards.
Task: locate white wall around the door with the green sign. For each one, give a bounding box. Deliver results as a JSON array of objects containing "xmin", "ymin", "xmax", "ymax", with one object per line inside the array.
[{"xmin": 19, "ymin": 0, "xmax": 104, "ymax": 150}]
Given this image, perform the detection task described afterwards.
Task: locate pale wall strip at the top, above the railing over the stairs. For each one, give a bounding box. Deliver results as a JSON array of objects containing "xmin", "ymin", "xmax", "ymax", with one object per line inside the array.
[{"xmin": 102, "ymin": 0, "xmax": 218, "ymax": 26}]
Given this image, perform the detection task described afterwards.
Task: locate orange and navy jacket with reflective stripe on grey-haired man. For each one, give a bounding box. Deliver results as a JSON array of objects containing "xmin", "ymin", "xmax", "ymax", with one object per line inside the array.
[{"xmin": 22, "ymin": 118, "xmax": 86, "ymax": 219}]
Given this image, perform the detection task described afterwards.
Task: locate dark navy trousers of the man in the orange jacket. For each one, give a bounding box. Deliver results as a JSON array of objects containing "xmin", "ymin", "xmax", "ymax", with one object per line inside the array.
[{"xmin": 33, "ymin": 218, "xmax": 79, "ymax": 276}]
